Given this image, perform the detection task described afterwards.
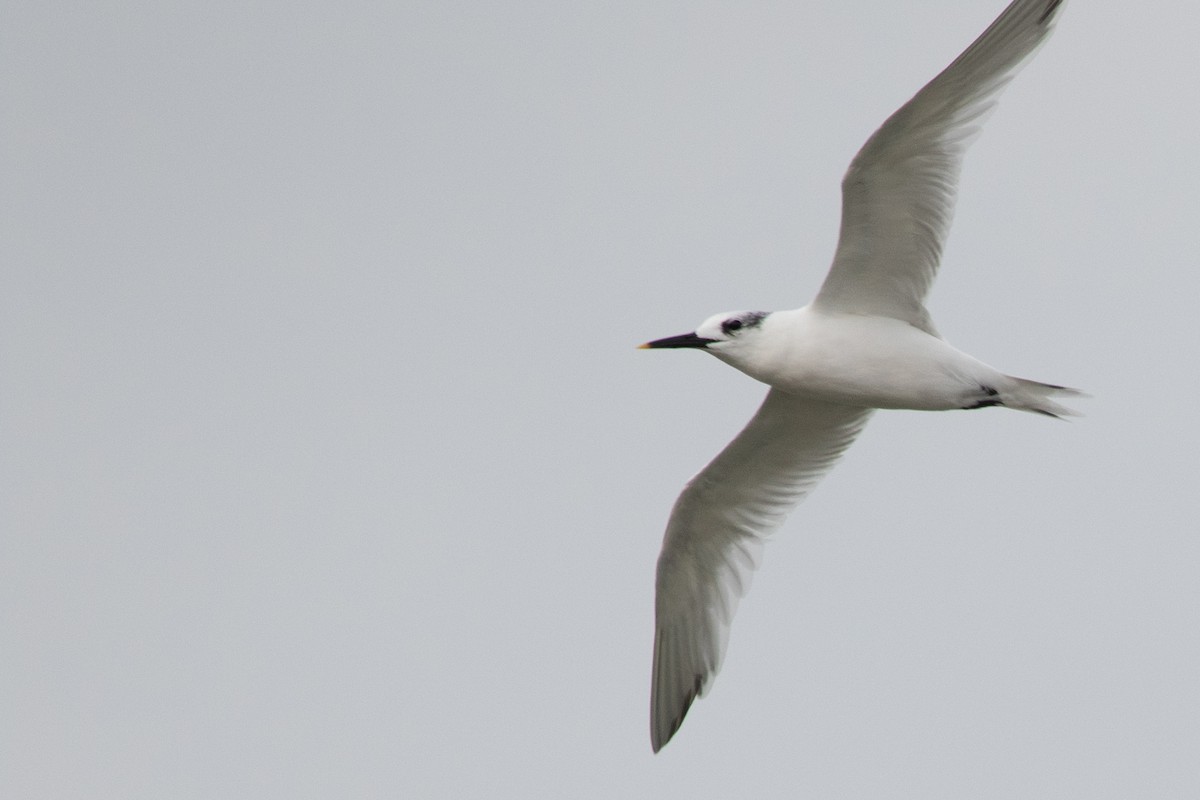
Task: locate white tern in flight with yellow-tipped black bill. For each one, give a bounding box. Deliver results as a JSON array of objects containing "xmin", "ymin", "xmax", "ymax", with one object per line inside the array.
[{"xmin": 641, "ymin": 0, "xmax": 1080, "ymax": 752}]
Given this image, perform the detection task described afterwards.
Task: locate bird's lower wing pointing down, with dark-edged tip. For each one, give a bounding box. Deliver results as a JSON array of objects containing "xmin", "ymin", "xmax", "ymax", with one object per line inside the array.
[{"xmin": 650, "ymin": 389, "xmax": 871, "ymax": 752}]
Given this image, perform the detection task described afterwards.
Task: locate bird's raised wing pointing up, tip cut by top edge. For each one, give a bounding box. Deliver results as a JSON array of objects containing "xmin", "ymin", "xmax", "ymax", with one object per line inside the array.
[{"xmin": 814, "ymin": 0, "xmax": 1062, "ymax": 335}]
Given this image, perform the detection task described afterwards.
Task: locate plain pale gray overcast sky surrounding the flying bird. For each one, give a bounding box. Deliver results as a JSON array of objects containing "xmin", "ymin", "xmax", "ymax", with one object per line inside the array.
[{"xmin": 0, "ymin": 0, "xmax": 1200, "ymax": 800}]
